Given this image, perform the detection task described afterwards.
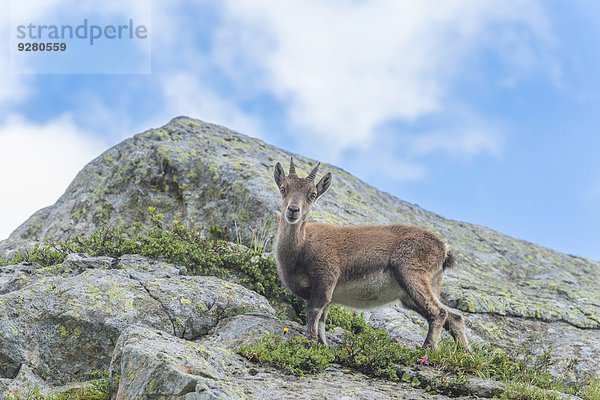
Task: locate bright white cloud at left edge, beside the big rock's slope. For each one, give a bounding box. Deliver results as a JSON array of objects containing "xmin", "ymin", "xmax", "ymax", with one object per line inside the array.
[{"xmin": 0, "ymin": 115, "xmax": 105, "ymax": 240}]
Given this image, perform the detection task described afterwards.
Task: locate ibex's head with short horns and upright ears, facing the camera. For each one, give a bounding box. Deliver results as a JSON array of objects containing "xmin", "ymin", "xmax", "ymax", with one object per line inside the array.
[{"xmin": 274, "ymin": 158, "xmax": 331, "ymax": 224}]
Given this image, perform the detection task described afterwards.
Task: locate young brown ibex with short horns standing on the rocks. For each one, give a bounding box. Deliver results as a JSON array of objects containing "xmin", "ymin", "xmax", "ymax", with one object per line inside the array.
[{"xmin": 274, "ymin": 159, "xmax": 469, "ymax": 349}]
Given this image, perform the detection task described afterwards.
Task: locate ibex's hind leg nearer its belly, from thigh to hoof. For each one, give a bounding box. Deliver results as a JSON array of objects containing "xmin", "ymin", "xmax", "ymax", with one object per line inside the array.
[{"xmin": 394, "ymin": 264, "xmax": 448, "ymax": 349}]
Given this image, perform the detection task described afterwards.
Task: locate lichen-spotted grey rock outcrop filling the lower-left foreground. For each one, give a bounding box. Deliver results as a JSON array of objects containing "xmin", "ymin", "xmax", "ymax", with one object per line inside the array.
[{"xmin": 0, "ymin": 254, "xmax": 489, "ymax": 400}]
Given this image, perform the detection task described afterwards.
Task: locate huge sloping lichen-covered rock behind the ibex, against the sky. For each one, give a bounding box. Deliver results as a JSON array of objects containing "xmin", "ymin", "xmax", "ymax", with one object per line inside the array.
[{"xmin": 0, "ymin": 117, "xmax": 600, "ymax": 329}]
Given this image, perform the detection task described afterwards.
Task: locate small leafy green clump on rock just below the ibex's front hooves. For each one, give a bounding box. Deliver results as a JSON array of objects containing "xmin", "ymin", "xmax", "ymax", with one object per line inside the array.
[{"xmin": 238, "ymin": 335, "xmax": 334, "ymax": 376}]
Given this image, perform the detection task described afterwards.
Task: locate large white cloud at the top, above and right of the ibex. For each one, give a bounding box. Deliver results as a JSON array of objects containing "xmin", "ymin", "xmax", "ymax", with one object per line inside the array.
[{"xmin": 214, "ymin": 0, "xmax": 558, "ymax": 158}]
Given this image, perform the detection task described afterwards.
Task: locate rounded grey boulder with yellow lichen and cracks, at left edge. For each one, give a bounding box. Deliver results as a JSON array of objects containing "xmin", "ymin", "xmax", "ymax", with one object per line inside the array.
[{"xmin": 0, "ymin": 255, "xmax": 274, "ymax": 384}]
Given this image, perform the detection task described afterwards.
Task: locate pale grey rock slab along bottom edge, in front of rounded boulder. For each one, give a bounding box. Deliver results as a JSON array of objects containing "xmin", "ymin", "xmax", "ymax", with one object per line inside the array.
[{"xmin": 110, "ymin": 324, "xmax": 480, "ymax": 400}]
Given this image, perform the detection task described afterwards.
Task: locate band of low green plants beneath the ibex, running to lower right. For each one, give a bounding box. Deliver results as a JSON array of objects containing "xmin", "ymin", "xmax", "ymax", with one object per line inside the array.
[{"xmin": 241, "ymin": 307, "xmax": 600, "ymax": 400}]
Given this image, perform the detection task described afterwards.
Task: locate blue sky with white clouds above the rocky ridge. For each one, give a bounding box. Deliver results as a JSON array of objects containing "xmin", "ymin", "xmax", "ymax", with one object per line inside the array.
[{"xmin": 0, "ymin": 0, "xmax": 600, "ymax": 260}]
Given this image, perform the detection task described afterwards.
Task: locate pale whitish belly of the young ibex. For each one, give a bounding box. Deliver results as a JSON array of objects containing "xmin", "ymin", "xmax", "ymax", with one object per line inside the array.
[{"xmin": 331, "ymin": 271, "xmax": 412, "ymax": 309}]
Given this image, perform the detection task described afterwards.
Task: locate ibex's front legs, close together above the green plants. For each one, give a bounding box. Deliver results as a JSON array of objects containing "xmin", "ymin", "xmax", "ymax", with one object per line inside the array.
[{"xmin": 306, "ymin": 278, "xmax": 336, "ymax": 344}]
